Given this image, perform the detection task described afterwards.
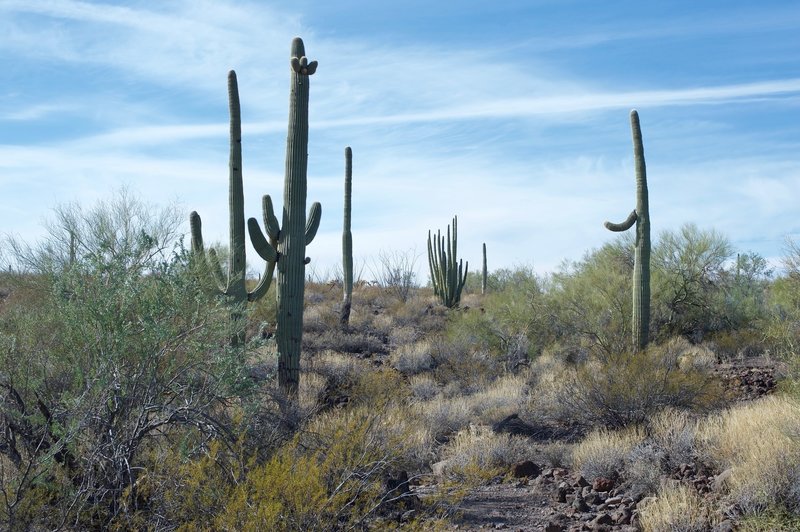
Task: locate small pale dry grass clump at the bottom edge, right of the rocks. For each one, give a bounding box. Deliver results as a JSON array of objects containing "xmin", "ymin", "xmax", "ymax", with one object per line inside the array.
[{"xmin": 639, "ymin": 485, "xmax": 712, "ymax": 532}]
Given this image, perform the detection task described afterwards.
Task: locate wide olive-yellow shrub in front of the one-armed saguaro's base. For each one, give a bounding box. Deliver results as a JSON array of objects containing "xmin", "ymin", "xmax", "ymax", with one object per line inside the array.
[{"xmin": 553, "ymin": 343, "xmax": 724, "ymax": 427}]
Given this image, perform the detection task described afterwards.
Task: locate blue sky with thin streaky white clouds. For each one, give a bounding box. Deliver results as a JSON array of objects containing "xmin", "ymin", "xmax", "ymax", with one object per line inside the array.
[{"xmin": 0, "ymin": 0, "xmax": 800, "ymax": 282}]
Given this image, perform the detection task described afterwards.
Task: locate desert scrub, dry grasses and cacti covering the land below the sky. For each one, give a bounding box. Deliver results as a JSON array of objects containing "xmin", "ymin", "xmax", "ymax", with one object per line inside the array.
[{"xmin": 0, "ymin": 35, "xmax": 800, "ymax": 531}]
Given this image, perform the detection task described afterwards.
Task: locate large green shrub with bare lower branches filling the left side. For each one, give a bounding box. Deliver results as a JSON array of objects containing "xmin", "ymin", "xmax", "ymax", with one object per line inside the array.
[{"xmin": 0, "ymin": 196, "xmax": 248, "ymax": 528}]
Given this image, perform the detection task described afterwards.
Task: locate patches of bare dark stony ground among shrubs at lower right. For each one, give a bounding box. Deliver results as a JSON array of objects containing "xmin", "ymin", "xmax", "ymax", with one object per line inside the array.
[{"xmin": 418, "ymin": 359, "xmax": 779, "ymax": 532}]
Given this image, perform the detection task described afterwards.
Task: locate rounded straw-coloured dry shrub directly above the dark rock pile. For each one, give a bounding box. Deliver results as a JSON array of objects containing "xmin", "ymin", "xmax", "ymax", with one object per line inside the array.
[{"xmin": 572, "ymin": 427, "xmax": 645, "ymax": 481}]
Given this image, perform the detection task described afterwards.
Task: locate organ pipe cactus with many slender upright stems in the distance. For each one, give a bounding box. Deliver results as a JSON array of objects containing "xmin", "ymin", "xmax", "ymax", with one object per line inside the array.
[{"xmin": 428, "ymin": 216, "xmax": 469, "ymax": 308}]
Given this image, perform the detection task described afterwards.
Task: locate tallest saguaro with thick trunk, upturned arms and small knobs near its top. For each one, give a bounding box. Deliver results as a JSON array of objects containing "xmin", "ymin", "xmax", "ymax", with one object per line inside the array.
[{"xmin": 252, "ymin": 37, "xmax": 322, "ymax": 395}]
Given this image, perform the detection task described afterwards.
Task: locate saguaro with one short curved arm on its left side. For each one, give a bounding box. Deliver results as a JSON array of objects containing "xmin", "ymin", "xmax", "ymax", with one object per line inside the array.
[{"xmin": 605, "ymin": 110, "xmax": 650, "ymax": 351}]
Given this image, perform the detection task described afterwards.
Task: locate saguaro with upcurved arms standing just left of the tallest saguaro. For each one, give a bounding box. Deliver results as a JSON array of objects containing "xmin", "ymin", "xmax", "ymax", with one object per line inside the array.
[{"xmin": 189, "ymin": 70, "xmax": 275, "ymax": 345}]
